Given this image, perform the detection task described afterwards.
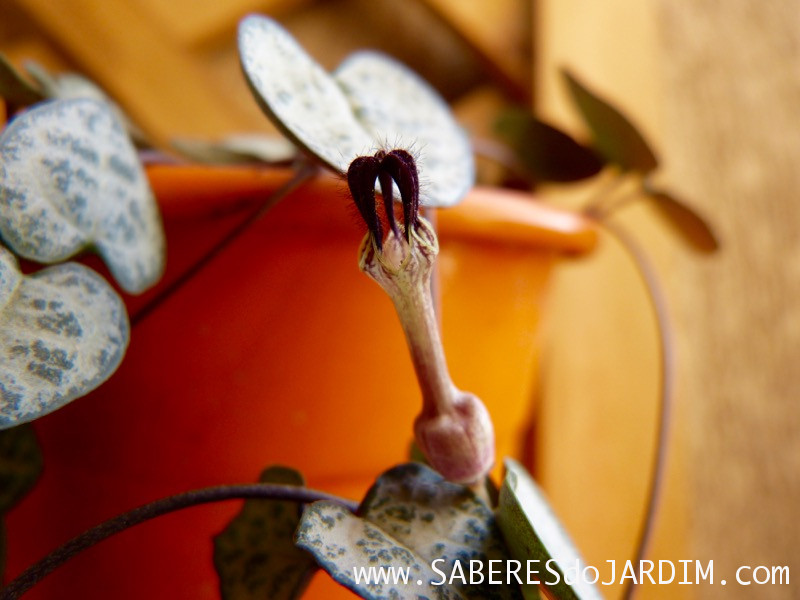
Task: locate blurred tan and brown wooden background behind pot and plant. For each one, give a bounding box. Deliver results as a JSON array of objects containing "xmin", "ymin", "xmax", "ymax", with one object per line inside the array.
[{"xmin": 0, "ymin": 0, "xmax": 800, "ymax": 598}]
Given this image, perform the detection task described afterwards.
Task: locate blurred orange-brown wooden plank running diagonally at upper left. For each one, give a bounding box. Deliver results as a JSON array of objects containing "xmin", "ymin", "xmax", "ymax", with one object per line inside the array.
[{"xmin": 11, "ymin": 0, "xmax": 262, "ymax": 139}]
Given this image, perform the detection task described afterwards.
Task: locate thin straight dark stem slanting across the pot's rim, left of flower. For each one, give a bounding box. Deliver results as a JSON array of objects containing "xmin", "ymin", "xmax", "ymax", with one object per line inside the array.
[{"xmin": 131, "ymin": 162, "xmax": 319, "ymax": 327}]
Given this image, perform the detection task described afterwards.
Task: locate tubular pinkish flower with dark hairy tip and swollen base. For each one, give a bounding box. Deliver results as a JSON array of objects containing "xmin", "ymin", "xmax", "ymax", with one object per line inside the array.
[{"xmin": 347, "ymin": 150, "xmax": 494, "ymax": 483}]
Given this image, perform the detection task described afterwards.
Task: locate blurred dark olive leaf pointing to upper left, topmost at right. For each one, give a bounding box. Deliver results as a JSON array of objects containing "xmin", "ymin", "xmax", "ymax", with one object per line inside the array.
[{"xmin": 562, "ymin": 70, "xmax": 658, "ymax": 173}]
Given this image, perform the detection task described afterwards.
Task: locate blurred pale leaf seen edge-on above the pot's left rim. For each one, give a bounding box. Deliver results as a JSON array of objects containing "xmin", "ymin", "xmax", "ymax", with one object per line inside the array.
[{"xmin": 172, "ymin": 134, "xmax": 297, "ymax": 165}]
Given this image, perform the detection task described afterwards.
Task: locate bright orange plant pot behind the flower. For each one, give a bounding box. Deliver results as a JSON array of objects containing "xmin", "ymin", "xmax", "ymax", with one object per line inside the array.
[{"xmin": 8, "ymin": 166, "xmax": 595, "ymax": 600}]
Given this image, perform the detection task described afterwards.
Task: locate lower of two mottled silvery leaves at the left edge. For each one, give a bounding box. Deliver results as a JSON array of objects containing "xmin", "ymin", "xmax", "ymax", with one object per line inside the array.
[{"xmin": 0, "ymin": 248, "xmax": 129, "ymax": 428}]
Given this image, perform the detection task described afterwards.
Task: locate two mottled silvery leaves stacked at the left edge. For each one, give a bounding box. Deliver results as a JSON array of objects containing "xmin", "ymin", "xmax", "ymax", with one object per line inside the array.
[{"xmin": 0, "ymin": 98, "xmax": 165, "ymax": 428}]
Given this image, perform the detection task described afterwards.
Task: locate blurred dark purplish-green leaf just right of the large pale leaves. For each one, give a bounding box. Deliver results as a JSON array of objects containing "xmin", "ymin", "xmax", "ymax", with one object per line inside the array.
[{"xmin": 495, "ymin": 109, "xmax": 604, "ymax": 182}]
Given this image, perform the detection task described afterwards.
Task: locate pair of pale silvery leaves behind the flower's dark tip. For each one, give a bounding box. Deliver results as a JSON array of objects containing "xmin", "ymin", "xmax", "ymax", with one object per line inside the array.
[{"xmin": 239, "ymin": 15, "xmax": 475, "ymax": 206}]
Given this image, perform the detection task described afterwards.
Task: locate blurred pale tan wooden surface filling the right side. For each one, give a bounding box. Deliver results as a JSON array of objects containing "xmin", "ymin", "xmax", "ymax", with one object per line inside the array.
[{"xmin": 537, "ymin": 0, "xmax": 800, "ymax": 598}]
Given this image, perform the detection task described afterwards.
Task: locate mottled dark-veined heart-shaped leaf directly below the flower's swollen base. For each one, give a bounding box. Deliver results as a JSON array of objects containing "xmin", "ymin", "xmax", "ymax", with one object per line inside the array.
[{"xmin": 297, "ymin": 463, "xmax": 524, "ymax": 600}]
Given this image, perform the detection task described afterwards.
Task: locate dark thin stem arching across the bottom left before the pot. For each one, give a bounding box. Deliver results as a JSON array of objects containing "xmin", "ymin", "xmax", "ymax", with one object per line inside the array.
[{"xmin": 0, "ymin": 483, "xmax": 358, "ymax": 600}]
